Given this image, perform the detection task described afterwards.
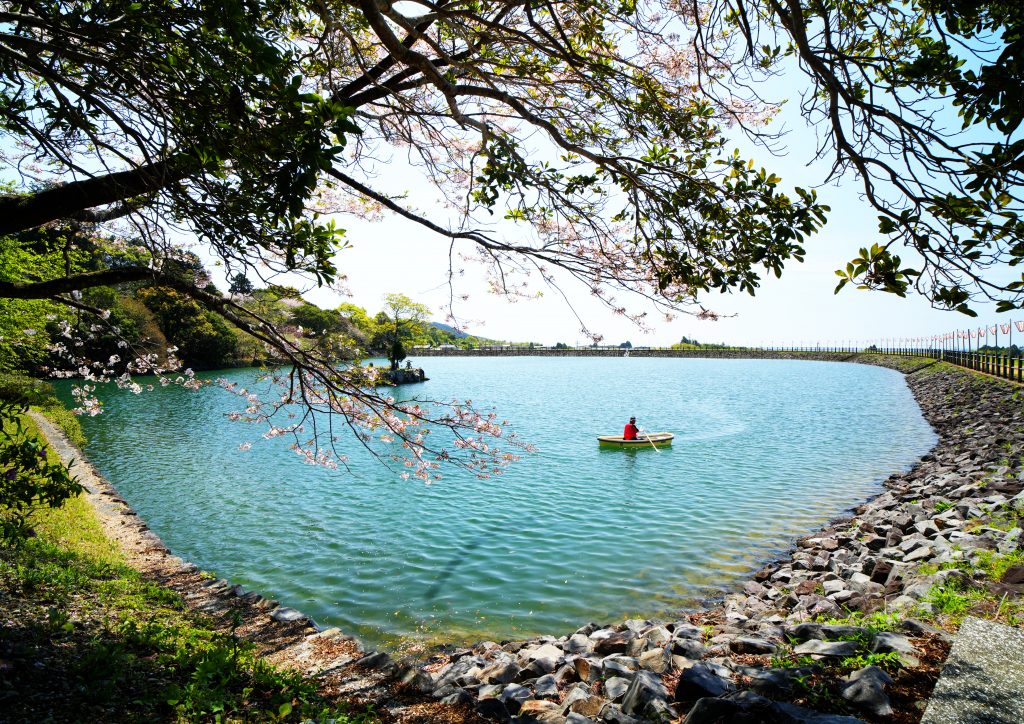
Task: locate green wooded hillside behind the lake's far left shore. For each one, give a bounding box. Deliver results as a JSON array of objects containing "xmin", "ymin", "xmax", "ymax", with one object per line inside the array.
[{"xmin": 0, "ymin": 233, "xmax": 494, "ymax": 377}]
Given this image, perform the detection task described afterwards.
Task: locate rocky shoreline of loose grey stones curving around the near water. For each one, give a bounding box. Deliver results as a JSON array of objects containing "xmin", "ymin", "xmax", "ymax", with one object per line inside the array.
[{"xmin": 34, "ymin": 355, "xmax": 1024, "ymax": 724}]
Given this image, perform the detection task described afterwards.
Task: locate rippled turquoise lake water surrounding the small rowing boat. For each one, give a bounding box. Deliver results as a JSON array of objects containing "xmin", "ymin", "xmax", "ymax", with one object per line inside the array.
[{"xmin": 68, "ymin": 357, "xmax": 935, "ymax": 644}]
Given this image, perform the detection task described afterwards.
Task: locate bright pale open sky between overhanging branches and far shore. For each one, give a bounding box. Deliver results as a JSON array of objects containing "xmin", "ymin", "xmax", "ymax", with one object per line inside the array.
[{"xmin": 276, "ymin": 27, "xmax": 1024, "ymax": 346}]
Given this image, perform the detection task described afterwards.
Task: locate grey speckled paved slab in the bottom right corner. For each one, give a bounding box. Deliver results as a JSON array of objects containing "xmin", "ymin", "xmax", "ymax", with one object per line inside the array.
[{"xmin": 921, "ymin": 619, "xmax": 1024, "ymax": 724}]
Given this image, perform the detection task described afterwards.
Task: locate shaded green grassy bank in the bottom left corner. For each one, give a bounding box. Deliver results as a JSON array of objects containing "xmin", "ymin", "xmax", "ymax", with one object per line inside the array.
[{"xmin": 0, "ymin": 416, "xmax": 374, "ymax": 724}]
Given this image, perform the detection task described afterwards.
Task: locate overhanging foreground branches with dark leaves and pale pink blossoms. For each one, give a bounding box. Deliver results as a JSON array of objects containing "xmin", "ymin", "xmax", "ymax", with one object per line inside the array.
[{"xmin": 0, "ymin": 0, "xmax": 1024, "ymax": 477}]
